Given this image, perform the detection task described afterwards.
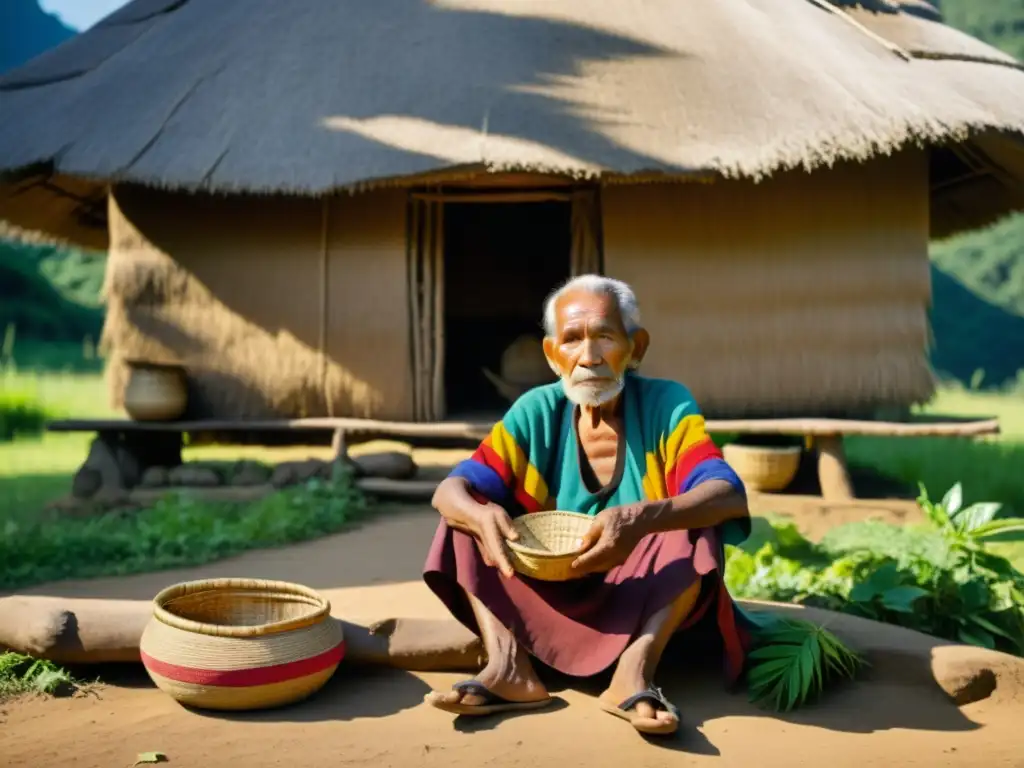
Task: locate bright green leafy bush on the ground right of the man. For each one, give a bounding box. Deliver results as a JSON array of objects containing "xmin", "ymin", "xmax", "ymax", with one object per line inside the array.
[{"xmin": 726, "ymin": 483, "xmax": 1024, "ymax": 655}]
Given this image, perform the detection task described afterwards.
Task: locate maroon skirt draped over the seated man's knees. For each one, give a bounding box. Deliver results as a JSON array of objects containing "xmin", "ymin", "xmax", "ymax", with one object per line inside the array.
[{"xmin": 423, "ymin": 520, "xmax": 749, "ymax": 682}]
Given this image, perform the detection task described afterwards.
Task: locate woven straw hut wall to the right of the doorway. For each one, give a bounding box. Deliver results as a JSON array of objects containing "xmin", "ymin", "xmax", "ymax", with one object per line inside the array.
[{"xmin": 603, "ymin": 152, "xmax": 934, "ymax": 415}]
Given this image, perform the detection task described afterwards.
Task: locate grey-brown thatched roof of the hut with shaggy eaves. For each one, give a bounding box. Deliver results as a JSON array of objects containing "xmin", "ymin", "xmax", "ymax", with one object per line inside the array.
[{"xmin": 0, "ymin": 0, "xmax": 1024, "ymax": 246}]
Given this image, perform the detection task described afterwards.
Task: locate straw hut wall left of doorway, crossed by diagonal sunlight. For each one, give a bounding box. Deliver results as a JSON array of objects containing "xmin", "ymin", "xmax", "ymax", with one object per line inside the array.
[{"xmin": 104, "ymin": 186, "xmax": 412, "ymax": 419}]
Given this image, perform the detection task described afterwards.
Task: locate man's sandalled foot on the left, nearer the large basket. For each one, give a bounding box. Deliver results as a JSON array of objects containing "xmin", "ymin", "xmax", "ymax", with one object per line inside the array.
[{"xmin": 423, "ymin": 649, "xmax": 552, "ymax": 715}]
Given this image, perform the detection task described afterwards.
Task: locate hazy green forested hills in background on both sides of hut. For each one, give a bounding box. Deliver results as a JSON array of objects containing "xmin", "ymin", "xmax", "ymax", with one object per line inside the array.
[{"xmin": 0, "ymin": 0, "xmax": 1024, "ymax": 389}]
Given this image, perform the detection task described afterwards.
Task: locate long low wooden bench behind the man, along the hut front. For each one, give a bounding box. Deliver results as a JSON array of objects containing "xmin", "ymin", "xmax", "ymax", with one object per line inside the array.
[{"xmin": 47, "ymin": 417, "xmax": 999, "ymax": 500}]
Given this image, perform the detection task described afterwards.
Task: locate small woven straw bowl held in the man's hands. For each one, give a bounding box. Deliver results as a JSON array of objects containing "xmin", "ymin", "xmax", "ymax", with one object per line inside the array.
[{"xmin": 508, "ymin": 511, "xmax": 594, "ymax": 582}]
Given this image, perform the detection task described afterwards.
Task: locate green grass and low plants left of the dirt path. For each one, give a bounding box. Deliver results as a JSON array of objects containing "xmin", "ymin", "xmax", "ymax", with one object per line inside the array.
[{"xmin": 0, "ymin": 371, "xmax": 374, "ymax": 591}]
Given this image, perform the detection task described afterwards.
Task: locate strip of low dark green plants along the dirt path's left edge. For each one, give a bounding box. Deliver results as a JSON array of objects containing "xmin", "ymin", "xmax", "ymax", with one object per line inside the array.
[{"xmin": 0, "ymin": 469, "xmax": 367, "ymax": 591}]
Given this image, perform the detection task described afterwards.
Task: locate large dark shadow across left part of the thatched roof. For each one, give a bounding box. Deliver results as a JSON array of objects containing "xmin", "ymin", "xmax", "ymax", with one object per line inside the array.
[{"xmin": 0, "ymin": 0, "xmax": 687, "ymax": 191}]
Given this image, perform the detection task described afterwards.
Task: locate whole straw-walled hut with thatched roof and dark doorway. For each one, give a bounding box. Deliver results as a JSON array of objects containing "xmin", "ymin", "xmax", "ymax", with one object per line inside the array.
[{"xmin": 0, "ymin": 0, "xmax": 1024, "ymax": 420}]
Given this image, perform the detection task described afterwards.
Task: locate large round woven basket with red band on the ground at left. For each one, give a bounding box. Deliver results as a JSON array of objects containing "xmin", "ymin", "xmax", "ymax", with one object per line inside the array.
[{"xmin": 140, "ymin": 579, "xmax": 345, "ymax": 710}]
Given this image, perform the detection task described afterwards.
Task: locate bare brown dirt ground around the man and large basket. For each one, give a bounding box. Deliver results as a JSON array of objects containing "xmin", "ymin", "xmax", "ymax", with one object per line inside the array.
[{"xmin": 0, "ymin": 500, "xmax": 1024, "ymax": 768}]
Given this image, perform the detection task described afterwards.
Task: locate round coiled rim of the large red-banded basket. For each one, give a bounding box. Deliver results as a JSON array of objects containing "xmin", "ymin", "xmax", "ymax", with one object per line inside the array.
[{"xmin": 153, "ymin": 579, "xmax": 331, "ymax": 638}]
